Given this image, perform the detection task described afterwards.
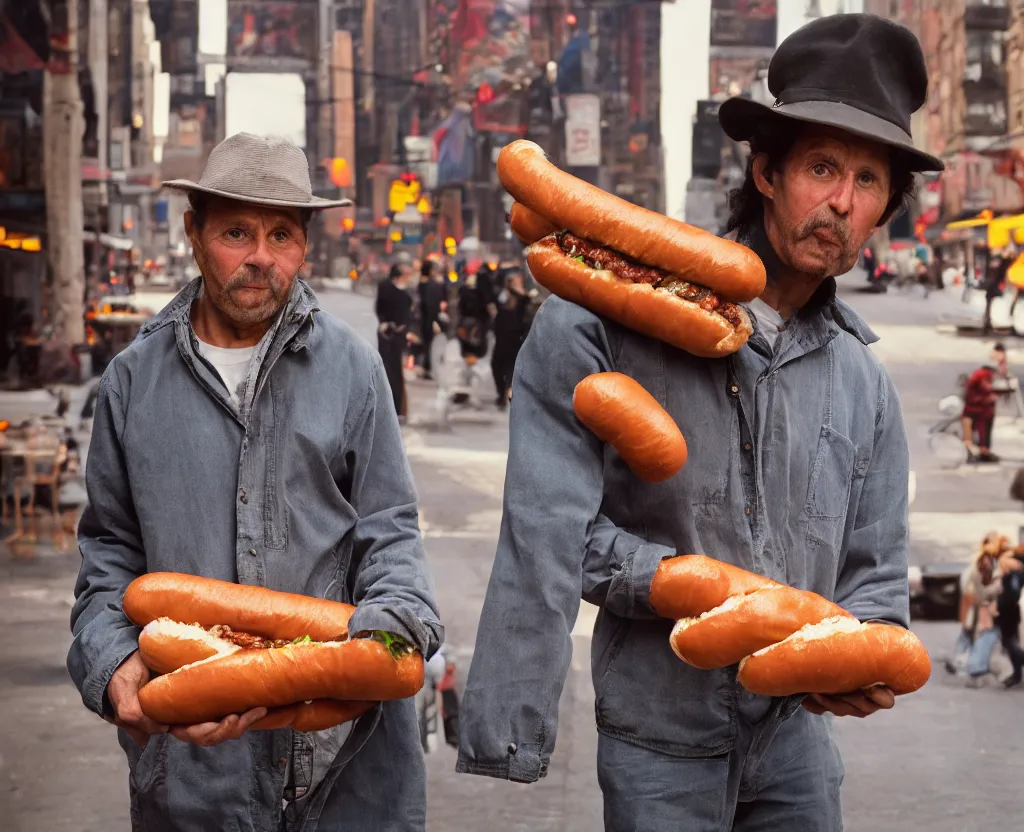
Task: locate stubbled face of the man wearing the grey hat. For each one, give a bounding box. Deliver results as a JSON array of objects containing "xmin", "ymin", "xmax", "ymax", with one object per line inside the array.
[{"xmin": 185, "ymin": 199, "xmax": 306, "ymax": 328}]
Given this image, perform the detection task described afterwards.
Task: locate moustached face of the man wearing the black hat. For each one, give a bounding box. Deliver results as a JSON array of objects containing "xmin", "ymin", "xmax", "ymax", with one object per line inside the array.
[{"xmin": 754, "ymin": 125, "xmax": 891, "ymax": 279}]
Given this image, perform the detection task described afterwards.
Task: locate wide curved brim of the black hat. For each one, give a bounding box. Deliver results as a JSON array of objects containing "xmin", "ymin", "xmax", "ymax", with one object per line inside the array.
[{"xmin": 718, "ymin": 98, "xmax": 945, "ymax": 172}]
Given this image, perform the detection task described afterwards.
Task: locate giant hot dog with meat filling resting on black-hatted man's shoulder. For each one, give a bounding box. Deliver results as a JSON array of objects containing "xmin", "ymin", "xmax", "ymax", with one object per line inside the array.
[{"xmin": 498, "ymin": 140, "xmax": 765, "ymax": 358}]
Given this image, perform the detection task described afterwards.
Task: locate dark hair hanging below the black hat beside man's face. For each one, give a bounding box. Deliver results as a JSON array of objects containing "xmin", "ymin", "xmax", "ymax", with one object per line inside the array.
[{"xmin": 725, "ymin": 119, "xmax": 914, "ymax": 234}]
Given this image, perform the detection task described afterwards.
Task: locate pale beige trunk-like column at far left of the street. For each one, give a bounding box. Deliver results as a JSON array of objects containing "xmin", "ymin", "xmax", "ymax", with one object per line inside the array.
[{"xmin": 43, "ymin": 0, "xmax": 85, "ymax": 356}]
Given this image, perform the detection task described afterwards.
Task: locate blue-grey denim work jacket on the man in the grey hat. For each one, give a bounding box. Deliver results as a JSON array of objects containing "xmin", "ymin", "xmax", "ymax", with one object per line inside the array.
[{"xmin": 68, "ymin": 281, "xmax": 443, "ymax": 832}]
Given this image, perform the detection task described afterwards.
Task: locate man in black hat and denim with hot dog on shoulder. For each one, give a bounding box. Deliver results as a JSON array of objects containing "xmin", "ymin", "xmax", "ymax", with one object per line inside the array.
[{"xmin": 458, "ymin": 14, "xmax": 942, "ymax": 832}]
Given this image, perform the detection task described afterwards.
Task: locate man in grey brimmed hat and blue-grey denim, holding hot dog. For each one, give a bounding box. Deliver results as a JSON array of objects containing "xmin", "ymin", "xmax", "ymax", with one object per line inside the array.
[{"xmin": 68, "ymin": 133, "xmax": 443, "ymax": 832}]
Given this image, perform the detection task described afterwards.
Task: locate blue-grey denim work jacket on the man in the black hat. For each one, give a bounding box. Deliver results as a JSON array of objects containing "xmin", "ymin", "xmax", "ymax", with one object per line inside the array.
[{"xmin": 457, "ymin": 266, "xmax": 909, "ymax": 782}]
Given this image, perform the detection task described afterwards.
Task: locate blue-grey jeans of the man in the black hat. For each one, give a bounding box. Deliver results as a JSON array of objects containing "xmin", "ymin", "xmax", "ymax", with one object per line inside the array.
[{"xmin": 597, "ymin": 708, "xmax": 844, "ymax": 832}]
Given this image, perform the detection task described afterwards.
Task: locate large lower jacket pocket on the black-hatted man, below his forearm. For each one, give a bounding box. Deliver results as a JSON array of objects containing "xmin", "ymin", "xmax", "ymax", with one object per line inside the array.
[{"xmin": 594, "ymin": 617, "xmax": 735, "ymax": 757}]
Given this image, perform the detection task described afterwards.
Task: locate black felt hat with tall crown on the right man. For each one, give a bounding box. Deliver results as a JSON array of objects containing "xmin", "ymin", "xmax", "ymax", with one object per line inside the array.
[{"xmin": 718, "ymin": 14, "xmax": 944, "ymax": 170}]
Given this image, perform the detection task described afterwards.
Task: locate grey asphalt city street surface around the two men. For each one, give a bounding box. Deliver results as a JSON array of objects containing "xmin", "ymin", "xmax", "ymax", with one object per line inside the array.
[{"xmin": 0, "ymin": 278, "xmax": 1024, "ymax": 832}]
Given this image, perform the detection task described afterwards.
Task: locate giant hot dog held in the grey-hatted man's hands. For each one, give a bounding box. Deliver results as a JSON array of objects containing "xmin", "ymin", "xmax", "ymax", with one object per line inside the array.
[{"xmin": 123, "ymin": 573, "xmax": 423, "ymax": 731}]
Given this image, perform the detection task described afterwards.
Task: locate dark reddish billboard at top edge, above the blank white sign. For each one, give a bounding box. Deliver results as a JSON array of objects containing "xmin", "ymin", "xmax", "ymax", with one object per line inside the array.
[{"xmin": 227, "ymin": 0, "xmax": 317, "ymax": 72}]
